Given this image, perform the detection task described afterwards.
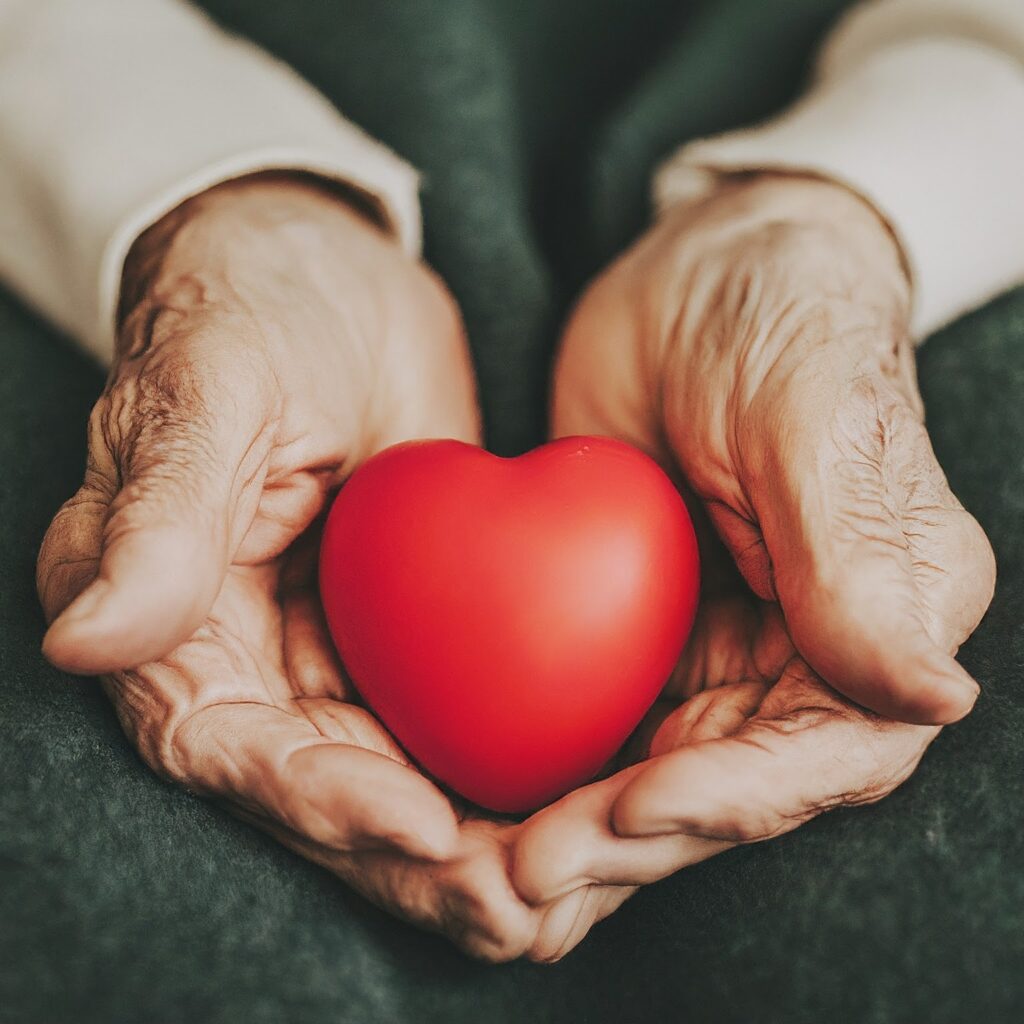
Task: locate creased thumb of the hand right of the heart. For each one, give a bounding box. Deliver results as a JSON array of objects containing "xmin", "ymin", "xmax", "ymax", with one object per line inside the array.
[{"xmin": 756, "ymin": 374, "xmax": 994, "ymax": 724}]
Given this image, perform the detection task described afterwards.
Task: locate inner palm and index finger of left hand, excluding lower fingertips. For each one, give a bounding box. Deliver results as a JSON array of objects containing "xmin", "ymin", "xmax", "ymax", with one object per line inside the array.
[{"xmin": 109, "ymin": 503, "xmax": 451, "ymax": 839}]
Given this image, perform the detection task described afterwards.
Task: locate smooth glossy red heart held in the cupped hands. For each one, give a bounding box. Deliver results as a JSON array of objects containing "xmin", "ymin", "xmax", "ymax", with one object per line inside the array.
[{"xmin": 321, "ymin": 437, "xmax": 699, "ymax": 812}]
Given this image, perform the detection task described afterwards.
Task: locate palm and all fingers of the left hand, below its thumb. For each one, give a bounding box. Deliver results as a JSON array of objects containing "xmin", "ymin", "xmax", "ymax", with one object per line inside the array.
[{"xmin": 121, "ymin": 528, "xmax": 628, "ymax": 959}]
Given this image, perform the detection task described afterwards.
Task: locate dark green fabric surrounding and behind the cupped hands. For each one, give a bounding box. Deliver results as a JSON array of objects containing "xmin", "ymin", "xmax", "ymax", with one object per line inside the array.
[{"xmin": 0, "ymin": 0, "xmax": 1024, "ymax": 1024}]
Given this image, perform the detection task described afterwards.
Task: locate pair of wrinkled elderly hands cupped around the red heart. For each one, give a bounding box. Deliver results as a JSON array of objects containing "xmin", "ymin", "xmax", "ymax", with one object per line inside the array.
[{"xmin": 38, "ymin": 169, "xmax": 994, "ymax": 961}]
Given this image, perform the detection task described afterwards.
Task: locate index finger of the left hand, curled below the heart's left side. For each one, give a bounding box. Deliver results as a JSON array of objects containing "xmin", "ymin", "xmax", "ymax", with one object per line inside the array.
[{"xmin": 165, "ymin": 703, "xmax": 458, "ymax": 860}]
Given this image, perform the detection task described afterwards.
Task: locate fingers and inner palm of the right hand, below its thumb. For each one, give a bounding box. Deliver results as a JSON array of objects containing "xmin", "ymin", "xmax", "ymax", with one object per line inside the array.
[{"xmin": 513, "ymin": 497, "xmax": 939, "ymax": 902}]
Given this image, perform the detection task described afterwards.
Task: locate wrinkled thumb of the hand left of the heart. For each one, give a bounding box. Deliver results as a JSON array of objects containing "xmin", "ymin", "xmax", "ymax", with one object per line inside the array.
[{"xmin": 40, "ymin": 353, "xmax": 269, "ymax": 674}]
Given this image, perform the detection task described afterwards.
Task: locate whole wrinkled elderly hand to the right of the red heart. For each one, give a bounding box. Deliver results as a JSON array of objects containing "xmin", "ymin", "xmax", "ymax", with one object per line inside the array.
[{"xmin": 513, "ymin": 175, "xmax": 994, "ymax": 902}]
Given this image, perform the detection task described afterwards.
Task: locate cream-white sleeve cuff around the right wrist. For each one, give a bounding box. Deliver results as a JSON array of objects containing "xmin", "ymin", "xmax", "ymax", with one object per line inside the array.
[{"xmin": 654, "ymin": 0, "xmax": 1024, "ymax": 339}]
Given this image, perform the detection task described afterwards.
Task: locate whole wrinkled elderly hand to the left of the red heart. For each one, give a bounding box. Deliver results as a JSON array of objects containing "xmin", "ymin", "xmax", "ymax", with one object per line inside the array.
[{"xmin": 38, "ymin": 177, "xmax": 623, "ymax": 958}]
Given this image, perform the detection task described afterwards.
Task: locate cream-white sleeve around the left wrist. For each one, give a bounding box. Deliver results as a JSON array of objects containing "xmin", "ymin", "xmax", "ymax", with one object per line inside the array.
[{"xmin": 0, "ymin": 0, "xmax": 420, "ymax": 358}]
